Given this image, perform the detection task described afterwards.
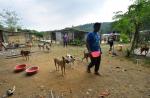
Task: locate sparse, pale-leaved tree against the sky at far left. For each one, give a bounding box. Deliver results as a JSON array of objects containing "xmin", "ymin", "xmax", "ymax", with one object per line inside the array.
[{"xmin": 0, "ymin": 9, "xmax": 20, "ymax": 31}]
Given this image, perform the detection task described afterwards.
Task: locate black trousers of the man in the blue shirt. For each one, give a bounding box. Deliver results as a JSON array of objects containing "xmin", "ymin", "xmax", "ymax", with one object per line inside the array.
[{"xmin": 88, "ymin": 56, "xmax": 101, "ymax": 72}]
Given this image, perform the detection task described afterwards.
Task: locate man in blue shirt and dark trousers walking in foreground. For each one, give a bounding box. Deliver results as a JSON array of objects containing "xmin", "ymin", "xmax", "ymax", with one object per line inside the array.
[{"xmin": 86, "ymin": 23, "xmax": 102, "ymax": 75}]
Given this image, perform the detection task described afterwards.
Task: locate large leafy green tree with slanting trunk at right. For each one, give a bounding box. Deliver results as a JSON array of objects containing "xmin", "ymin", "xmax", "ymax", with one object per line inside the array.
[{"xmin": 112, "ymin": 0, "xmax": 150, "ymax": 54}]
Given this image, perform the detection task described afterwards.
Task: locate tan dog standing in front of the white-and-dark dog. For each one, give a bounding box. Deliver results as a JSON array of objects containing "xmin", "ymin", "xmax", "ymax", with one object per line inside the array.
[{"xmin": 54, "ymin": 57, "xmax": 66, "ymax": 76}]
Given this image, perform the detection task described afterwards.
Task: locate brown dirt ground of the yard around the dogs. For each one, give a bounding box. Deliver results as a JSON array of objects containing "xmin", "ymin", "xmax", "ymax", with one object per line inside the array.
[{"xmin": 0, "ymin": 46, "xmax": 150, "ymax": 98}]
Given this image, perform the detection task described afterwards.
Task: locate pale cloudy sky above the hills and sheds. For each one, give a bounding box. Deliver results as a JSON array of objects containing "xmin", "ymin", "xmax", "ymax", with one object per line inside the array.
[{"xmin": 0, "ymin": 0, "xmax": 133, "ymax": 31}]
